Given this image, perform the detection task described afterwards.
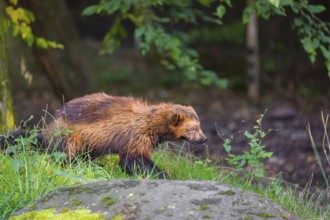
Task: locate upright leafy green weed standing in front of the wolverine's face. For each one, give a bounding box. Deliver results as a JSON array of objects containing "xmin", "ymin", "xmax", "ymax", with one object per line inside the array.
[{"xmin": 223, "ymin": 114, "xmax": 273, "ymax": 184}]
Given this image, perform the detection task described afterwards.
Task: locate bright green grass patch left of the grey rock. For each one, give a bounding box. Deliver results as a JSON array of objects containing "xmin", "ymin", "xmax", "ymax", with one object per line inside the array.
[{"xmin": 0, "ymin": 144, "xmax": 127, "ymax": 219}]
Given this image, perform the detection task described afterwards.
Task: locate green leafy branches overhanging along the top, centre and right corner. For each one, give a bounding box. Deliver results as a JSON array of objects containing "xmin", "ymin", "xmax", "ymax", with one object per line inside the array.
[{"xmin": 83, "ymin": 0, "xmax": 330, "ymax": 88}]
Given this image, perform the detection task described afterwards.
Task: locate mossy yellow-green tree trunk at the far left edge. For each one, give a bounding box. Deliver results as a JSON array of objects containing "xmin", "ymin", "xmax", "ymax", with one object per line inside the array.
[{"xmin": 0, "ymin": 0, "xmax": 15, "ymax": 132}]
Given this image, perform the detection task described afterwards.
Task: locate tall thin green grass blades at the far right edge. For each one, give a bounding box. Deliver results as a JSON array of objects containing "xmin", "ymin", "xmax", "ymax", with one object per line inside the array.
[{"xmin": 307, "ymin": 112, "xmax": 330, "ymax": 190}]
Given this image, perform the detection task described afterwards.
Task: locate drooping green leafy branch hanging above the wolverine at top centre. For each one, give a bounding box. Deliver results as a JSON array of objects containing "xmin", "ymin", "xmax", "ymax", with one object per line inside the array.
[{"xmin": 83, "ymin": 0, "xmax": 230, "ymax": 88}]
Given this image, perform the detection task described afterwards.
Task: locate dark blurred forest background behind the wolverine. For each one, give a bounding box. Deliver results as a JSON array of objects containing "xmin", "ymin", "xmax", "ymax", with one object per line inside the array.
[{"xmin": 5, "ymin": 0, "xmax": 330, "ymax": 186}]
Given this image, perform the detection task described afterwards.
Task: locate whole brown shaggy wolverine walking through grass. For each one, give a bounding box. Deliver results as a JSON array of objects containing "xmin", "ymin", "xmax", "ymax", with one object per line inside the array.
[{"xmin": 0, "ymin": 93, "xmax": 207, "ymax": 178}]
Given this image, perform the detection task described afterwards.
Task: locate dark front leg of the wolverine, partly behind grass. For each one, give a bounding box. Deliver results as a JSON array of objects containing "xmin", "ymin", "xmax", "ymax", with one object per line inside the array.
[{"xmin": 119, "ymin": 155, "xmax": 169, "ymax": 179}]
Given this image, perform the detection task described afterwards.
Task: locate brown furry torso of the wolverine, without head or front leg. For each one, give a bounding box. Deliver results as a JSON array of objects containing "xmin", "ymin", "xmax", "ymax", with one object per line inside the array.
[{"xmin": 46, "ymin": 93, "xmax": 149, "ymax": 158}]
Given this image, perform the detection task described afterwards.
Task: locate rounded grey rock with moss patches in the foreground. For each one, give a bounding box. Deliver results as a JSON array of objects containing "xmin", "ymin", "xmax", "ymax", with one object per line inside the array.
[{"xmin": 15, "ymin": 179, "xmax": 298, "ymax": 220}]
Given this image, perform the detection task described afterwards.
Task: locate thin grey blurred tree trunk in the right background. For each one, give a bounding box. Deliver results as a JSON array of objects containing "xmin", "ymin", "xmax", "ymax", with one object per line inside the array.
[{"xmin": 246, "ymin": 0, "xmax": 260, "ymax": 104}]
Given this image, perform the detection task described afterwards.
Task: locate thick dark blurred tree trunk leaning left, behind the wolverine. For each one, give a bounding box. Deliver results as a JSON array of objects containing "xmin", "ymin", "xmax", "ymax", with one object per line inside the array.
[{"xmin": 22, "ymin": 0, "xmax": 92, "ymax": 100}]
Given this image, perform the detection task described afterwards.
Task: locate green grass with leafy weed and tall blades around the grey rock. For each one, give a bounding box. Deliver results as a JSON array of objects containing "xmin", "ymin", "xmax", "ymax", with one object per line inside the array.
[{"xmin": 0, "ymin": 114, "xmax": 330, "ymax": 219}]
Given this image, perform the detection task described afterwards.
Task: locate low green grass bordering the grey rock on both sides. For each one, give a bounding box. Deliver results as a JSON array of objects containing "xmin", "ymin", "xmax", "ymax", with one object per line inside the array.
[{"xmin": 0, "ymin": 144, "xmax": 330, "ymax": 219}]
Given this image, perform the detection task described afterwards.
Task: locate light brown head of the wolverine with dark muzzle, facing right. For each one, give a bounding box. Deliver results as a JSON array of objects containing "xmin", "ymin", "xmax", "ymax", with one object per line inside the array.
[{"xmin": 169, "ymin": 105, "xmax": 207, "ymax": 144}]
